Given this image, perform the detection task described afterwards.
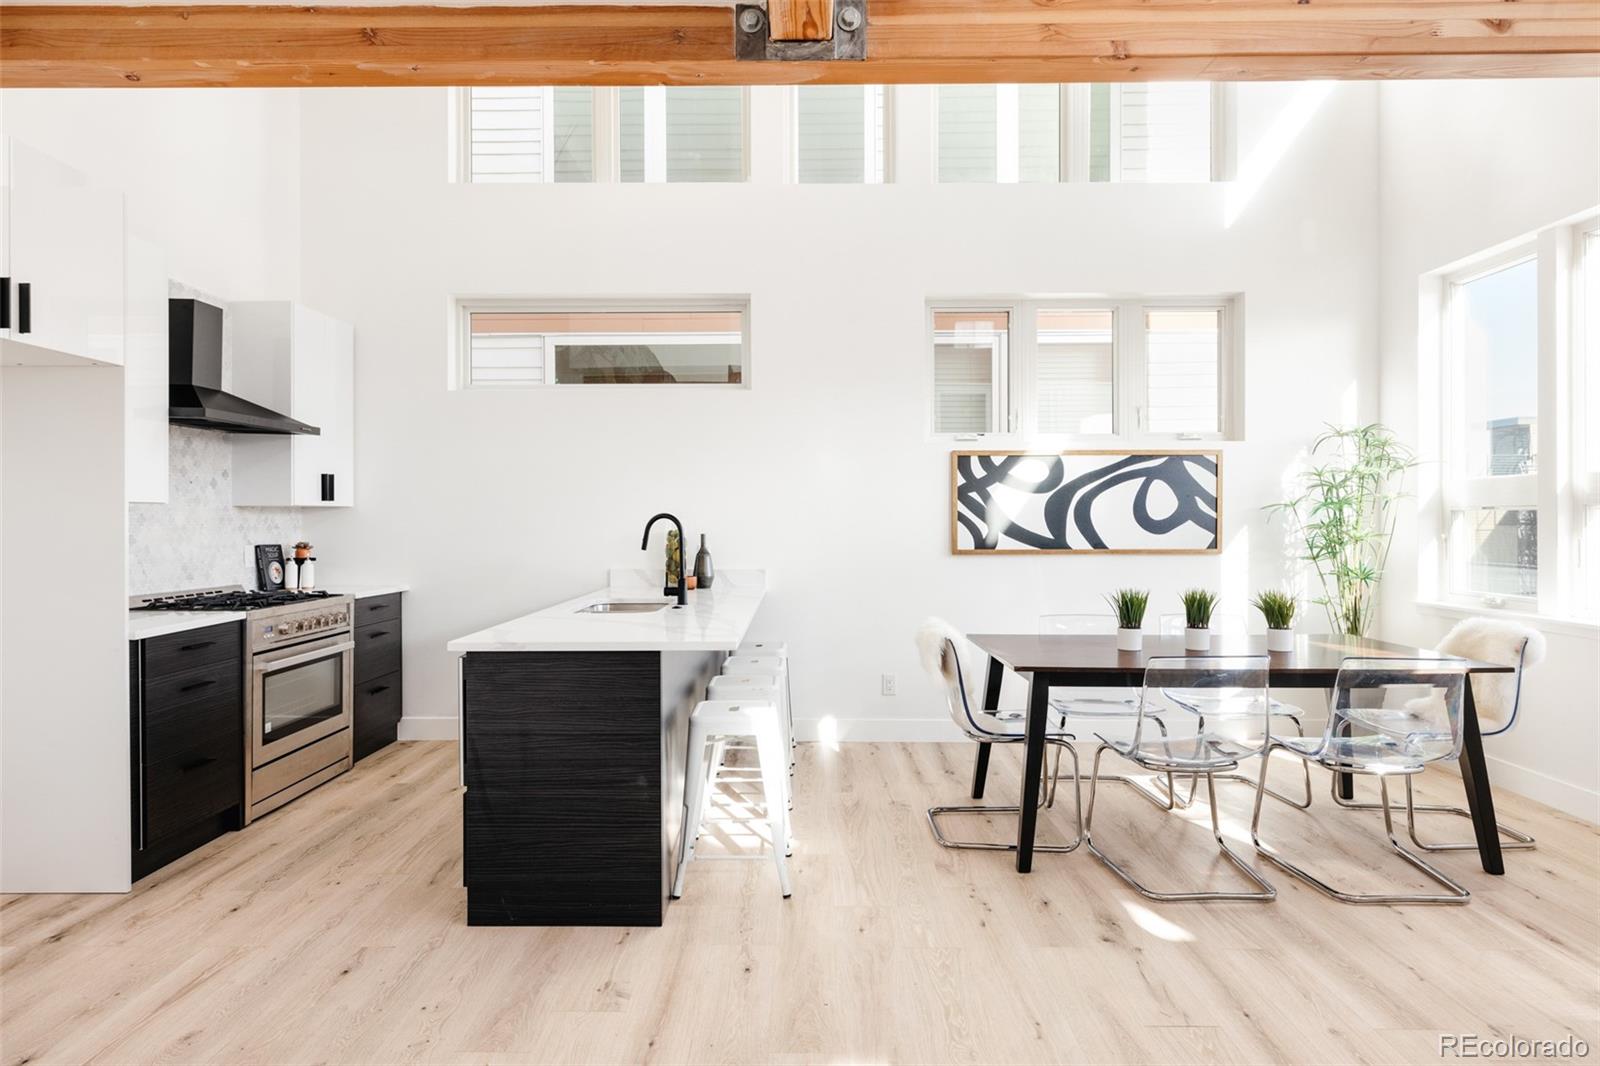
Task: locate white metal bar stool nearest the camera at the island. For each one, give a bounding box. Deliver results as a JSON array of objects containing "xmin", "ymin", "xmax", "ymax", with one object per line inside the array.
[{"xmin": 672, "ymin": 699, "xmax": 794, "ymax": 900}]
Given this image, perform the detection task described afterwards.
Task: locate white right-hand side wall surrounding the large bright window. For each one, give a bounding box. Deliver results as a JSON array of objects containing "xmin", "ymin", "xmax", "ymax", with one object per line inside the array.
[{"xmin": 1378, "ymin": 78, "xmax": 1600, "ymax": 821}]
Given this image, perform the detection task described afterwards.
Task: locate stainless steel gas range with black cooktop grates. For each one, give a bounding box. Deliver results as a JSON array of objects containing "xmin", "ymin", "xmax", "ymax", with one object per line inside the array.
[{"xmin": 131, "ymin": 586, "xmax": 355, "ymax": 823}]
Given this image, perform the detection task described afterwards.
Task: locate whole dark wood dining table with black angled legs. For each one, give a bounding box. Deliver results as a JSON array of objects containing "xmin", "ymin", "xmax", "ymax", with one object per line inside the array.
[{"xmin": 970, "ymin": 634, "xmax": 1512, "ymax": 874}]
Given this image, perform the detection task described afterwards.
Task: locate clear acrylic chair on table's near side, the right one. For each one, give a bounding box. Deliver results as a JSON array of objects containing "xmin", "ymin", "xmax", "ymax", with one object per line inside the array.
[{"xmin": 1250, "ymin": 658, "xmax": 1470, "ymax": 904}]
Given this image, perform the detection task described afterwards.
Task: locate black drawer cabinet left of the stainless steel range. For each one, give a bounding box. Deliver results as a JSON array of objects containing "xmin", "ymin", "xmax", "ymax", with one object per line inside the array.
[{"xmin": 128, "ymin": 623, "xmax": 245, "ymax": 880}]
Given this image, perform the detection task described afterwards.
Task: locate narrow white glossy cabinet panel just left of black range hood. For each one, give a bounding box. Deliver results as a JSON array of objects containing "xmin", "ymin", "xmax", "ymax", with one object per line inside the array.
[{"xmin": 123, "ymin": 232, "xmax": 168, "ymax": 503}]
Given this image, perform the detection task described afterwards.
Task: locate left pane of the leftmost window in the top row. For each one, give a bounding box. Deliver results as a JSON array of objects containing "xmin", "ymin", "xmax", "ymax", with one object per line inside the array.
[{"xmin": 466, "ymin": 86, "xmax": 594, "ymax": 182}]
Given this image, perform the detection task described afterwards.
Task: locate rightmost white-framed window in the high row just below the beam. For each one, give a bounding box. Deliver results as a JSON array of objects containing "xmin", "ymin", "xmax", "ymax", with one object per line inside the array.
[{"xmin": 938, "ymin": 82, "xmax": 1224, "ymax": 182}]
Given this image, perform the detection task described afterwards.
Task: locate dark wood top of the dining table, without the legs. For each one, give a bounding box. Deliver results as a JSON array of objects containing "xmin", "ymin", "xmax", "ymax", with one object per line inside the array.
[{"xmin": 970, "ymin": 634, "xmax": 1512, "ymax": 688}]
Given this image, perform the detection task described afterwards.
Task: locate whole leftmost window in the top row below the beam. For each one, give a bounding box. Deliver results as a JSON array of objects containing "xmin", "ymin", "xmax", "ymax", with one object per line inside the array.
[{"xmin": 458, "ymin": 85, "xmax": 749, "ymax": 182}]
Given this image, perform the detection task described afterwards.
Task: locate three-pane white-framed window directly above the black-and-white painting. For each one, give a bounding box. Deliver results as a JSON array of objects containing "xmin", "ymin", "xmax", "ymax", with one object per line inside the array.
[{"xmin": 930, "ymin": 296, "xmax": 1238, "ymax": 440}]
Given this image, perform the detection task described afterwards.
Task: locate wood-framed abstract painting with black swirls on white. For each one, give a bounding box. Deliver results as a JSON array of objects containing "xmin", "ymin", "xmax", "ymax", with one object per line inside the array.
[{"xmin": 950, "ymin": 451, "xmax": 1222, "ymax": 554}]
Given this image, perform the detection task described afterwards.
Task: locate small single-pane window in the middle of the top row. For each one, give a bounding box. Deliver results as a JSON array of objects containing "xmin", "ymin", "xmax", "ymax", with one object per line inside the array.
[{"xmin": 792, "ymin": 85, "xmax": 888, "ymax": 184}]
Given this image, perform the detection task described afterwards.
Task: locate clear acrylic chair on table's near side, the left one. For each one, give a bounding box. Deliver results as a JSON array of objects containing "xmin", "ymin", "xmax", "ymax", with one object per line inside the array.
[{"xmin": 1083, "ymin": 655, "xmax": 1277, "ymax": 903}]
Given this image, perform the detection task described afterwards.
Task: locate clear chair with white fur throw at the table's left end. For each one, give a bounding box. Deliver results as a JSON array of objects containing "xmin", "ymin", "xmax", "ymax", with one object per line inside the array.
[{"xmin": 917, "ymin": 618, "xmax": 1083, "ymax": 853}]
